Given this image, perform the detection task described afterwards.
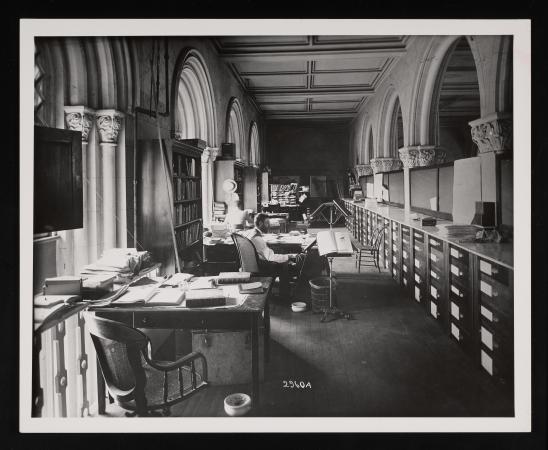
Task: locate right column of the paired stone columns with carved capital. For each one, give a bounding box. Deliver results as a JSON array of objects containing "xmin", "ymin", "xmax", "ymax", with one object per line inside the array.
[{"xmin": 95, "ymin": 109, "xmax": 123, "ymax": 250}]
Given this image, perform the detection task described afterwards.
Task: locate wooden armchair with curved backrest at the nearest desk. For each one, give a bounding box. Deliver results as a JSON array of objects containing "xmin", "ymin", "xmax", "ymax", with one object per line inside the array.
[{"xmin": 85, "ymin": 312, "xmax": 207, "ymax": 416}]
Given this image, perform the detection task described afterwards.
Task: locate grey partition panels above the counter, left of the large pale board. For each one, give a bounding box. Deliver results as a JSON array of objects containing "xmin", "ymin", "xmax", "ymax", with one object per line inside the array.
[{"xmin": 409, "ymin": 163, "xmax": 453, "ymax": 220}]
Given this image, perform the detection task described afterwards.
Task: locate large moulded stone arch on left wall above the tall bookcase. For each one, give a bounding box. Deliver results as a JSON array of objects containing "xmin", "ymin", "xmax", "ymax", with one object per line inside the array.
[{"xmin": 171, "ymin": 49, "xmax": 217, "ymax": 147}]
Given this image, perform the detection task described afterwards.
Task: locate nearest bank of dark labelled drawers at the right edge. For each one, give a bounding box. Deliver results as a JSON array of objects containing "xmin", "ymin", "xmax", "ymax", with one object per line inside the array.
[{"xmin": 477, "ymin": 257, "xmax": 514, "ymax": 386}]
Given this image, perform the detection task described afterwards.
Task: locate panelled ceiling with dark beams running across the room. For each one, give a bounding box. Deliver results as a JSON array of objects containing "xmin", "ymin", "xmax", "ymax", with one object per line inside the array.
[{"xmin": 214, "ymin": 35, "xmax": 409, "ymax": 119}]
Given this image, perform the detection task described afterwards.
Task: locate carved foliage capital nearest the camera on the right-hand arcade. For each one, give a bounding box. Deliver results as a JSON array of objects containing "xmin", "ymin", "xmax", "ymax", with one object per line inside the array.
[{"xmin": 468, "ymin": 113, "xmax": 513, "ymax": 154}]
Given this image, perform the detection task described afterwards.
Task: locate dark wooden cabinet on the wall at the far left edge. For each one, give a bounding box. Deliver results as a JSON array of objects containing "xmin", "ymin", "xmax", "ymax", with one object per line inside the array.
[{"xmin": 34, "ymin": 126, "xmax": 83, "ymax": 233}]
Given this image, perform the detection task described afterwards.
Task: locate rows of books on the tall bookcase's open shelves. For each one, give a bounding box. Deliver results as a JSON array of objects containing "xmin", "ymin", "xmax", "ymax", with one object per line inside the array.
[{"xmin": 172, "ymin": 147, "xmax": 203, "ymax": 257}]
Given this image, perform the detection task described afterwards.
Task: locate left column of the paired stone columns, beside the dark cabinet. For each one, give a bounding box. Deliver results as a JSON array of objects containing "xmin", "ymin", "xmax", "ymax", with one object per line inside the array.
[{"xmin": 65, "ymin": 106, "xmax": 95, "ymax": 272}]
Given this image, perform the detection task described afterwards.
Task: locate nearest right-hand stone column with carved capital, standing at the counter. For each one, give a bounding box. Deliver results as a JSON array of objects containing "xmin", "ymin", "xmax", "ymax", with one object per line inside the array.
[{"xmin": 469, "ymin": 112, "xmax": 513, "ymax": 221}]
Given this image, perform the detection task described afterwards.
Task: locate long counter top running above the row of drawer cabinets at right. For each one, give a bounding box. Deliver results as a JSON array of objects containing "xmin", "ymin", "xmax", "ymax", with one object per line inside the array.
[{"xmin": 344, "ymin": 199, "xmax": 514, "ymax": 270}]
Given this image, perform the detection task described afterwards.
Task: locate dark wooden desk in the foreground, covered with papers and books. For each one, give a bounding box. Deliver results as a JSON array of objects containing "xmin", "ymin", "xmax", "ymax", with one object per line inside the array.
[{"xmin": 90, "ymin": 277, "xmax": 273, "ymax": 414}]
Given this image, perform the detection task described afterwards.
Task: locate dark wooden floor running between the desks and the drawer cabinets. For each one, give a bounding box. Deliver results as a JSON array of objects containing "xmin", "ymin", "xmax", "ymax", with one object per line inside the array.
[{"xmin": 99, "ymin": 243, "xmax": 513, "ymax": 417}]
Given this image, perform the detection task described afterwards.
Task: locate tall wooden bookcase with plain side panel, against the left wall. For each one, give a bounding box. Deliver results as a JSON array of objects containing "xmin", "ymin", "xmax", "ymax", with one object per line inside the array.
[{"xmin": 136, "ymin": 139, "xmax": 203, "ymax": 273}]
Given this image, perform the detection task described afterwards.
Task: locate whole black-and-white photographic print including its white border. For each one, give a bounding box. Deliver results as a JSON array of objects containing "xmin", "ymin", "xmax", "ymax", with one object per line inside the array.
[{"xmin": 19, "ymin": 19, "xmax": 531, "ymax": 433}]
